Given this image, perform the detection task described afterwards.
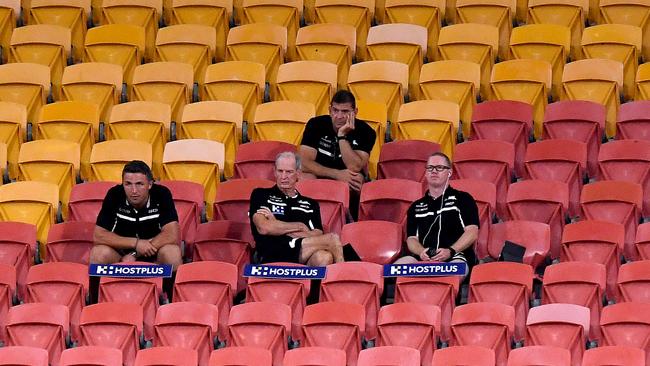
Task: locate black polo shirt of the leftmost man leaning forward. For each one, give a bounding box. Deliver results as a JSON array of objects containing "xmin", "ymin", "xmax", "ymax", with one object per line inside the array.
[{"xmin": 97, "ymin": 184, "xmax": 178, "ymax": 239}]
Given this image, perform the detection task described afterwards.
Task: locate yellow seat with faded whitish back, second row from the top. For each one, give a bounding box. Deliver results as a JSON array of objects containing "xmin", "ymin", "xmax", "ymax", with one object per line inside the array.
[{"xmin": 367, "ymin": 24, "xmax": 427, "ymax": 99}]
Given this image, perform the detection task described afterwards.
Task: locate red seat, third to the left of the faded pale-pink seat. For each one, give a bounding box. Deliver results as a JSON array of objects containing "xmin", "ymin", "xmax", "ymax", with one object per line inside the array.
[{"xmin": 301, "ymin": 301, "xmax": 366, "ymax": 366}]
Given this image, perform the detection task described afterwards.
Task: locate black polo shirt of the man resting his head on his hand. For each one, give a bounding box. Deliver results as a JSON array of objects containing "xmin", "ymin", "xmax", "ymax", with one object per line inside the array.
[{"xmin": 301, "ymin": 114, "xmax": 376, "ymax": 170}]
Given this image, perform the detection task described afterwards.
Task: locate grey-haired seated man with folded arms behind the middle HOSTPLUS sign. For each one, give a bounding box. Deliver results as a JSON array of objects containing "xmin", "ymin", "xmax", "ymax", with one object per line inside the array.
[{"xmin": 248, "ymin": 152, "xmax": 343, "ymax": 266}]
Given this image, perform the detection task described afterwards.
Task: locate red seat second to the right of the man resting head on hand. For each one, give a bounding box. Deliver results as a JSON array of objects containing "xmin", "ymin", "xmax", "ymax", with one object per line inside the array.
[{"xmin": 452, "ymin": 140, "xmax": 515, "ymax": 217}]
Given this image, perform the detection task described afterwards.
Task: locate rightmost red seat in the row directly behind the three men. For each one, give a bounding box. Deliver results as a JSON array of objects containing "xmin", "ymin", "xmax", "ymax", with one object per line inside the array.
[{"xmin": 580, "ymin": 181, "xmax": 643, "ymax": 259}]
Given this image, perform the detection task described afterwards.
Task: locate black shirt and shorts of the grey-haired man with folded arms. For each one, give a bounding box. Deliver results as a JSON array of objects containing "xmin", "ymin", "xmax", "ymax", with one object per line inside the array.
[{"xmin": 248, "ymin": 185, "xmax": 323, "ymax": 262}]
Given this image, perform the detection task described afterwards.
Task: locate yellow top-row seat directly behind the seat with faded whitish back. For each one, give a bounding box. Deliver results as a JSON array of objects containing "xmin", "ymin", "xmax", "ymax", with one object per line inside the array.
[{"xmin": 384, "ymin": 0, "xmax": 446, "ymax": 61}]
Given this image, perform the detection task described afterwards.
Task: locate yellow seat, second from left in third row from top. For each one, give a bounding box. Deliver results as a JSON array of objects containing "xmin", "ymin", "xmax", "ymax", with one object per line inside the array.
[{"xmin": 61, "ymin": 62, "xmax": 122, "ymax": 121}]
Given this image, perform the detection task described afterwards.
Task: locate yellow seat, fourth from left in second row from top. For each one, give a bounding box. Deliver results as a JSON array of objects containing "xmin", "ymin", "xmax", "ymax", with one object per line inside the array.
[{"xmin": 226, "ymin": 23, "xmax": 287, "ymax": 84}]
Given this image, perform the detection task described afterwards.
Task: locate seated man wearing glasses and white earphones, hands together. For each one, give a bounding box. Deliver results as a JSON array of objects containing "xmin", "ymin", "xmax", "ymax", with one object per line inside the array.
[{"xmin": 396, "ymin": 152, "xmax": 479, "ymax": 274}]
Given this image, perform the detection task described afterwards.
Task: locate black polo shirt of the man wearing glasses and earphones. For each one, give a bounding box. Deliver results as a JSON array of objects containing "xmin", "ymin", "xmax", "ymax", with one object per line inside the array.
[{"xmin": 406, "ymin": 187, "xmax": 479, "ymax": 265}]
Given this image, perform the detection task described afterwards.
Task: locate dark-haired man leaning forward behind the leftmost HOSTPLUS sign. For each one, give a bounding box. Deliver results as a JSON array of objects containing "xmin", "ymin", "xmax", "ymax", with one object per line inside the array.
[{"xmin": 90, "ymin": 160, "xmax": 182, "ymax": 268}]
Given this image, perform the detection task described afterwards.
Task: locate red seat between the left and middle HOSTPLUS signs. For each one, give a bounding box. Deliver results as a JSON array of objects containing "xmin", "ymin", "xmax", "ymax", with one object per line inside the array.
[{"xmin": 172, "ymin": 261, "xmax": 238, "ymax": 340}]
